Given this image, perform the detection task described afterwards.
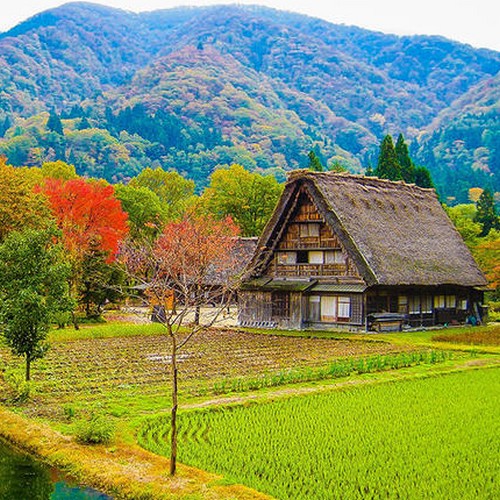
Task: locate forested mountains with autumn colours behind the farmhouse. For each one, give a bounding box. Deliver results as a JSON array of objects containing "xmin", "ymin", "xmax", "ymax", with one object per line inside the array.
[{"xmin": 0, "ymin": 3, "xmax": 500, "ymax": 195}]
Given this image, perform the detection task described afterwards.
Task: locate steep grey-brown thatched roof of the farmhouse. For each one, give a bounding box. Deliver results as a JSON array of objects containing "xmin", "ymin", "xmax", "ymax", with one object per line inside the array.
[{"xmin": 244, "ymin": 170, "xmax": 486, "ymax": 286}]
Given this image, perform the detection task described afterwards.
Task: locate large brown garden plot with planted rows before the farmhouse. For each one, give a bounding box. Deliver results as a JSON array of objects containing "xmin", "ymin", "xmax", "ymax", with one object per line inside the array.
[{"xmin": 1, "ymin": 330, "xmax": 414, "ymax": 413}]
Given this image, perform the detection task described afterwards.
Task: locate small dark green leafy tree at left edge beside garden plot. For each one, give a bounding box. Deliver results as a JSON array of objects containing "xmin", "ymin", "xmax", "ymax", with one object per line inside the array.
[{"xmin": 0, "ymin": 229, "xmax": 73, "ymax": 381}]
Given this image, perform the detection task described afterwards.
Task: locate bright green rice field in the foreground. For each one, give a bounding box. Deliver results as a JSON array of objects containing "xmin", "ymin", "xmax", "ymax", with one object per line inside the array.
[{"xmin": 138, "ymin": 368, "xmax": 500, "ymax": 500}]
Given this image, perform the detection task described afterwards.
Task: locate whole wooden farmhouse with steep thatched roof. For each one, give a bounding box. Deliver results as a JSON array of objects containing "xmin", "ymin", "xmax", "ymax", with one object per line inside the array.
[{"xmin": 239, "ymin": 172, "xmax": 486, "ymax": 330}]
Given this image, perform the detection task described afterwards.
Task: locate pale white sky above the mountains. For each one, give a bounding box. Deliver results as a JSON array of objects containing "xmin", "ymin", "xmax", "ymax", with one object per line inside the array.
[{"xmin": 0, "ymin": 0, "xmax": 500, "ymax": 51}]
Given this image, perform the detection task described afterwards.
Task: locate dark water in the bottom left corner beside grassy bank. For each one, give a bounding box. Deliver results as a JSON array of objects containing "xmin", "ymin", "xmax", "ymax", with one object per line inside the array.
[{"xmin": 0, "ymin": 440, "xmax": 111, "ymax": 500}]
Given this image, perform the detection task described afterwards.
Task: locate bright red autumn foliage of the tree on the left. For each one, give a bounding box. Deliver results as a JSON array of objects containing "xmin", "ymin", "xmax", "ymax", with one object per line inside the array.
[{"xmin": 41, "ymin": 178, "xmax": 128, "ymax": 262}]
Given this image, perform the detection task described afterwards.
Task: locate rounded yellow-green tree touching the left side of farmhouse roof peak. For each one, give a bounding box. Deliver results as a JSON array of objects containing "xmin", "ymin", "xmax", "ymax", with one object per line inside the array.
[{"xmin": 200, "ymin": 165, "xmax": 283, "ymax": 236}]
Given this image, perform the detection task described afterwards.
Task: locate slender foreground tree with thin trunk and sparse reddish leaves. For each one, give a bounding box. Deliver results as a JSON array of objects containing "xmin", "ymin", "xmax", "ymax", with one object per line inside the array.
[{"xmin": 121, "ymin": 216, "xmax": 238, "ymax": 475}]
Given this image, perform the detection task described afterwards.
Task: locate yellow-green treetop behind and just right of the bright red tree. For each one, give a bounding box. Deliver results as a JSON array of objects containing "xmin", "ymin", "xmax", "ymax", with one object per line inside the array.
[{"xmin": 129, "ymin": 168, "xmax": 195, "ymax": 220}]
